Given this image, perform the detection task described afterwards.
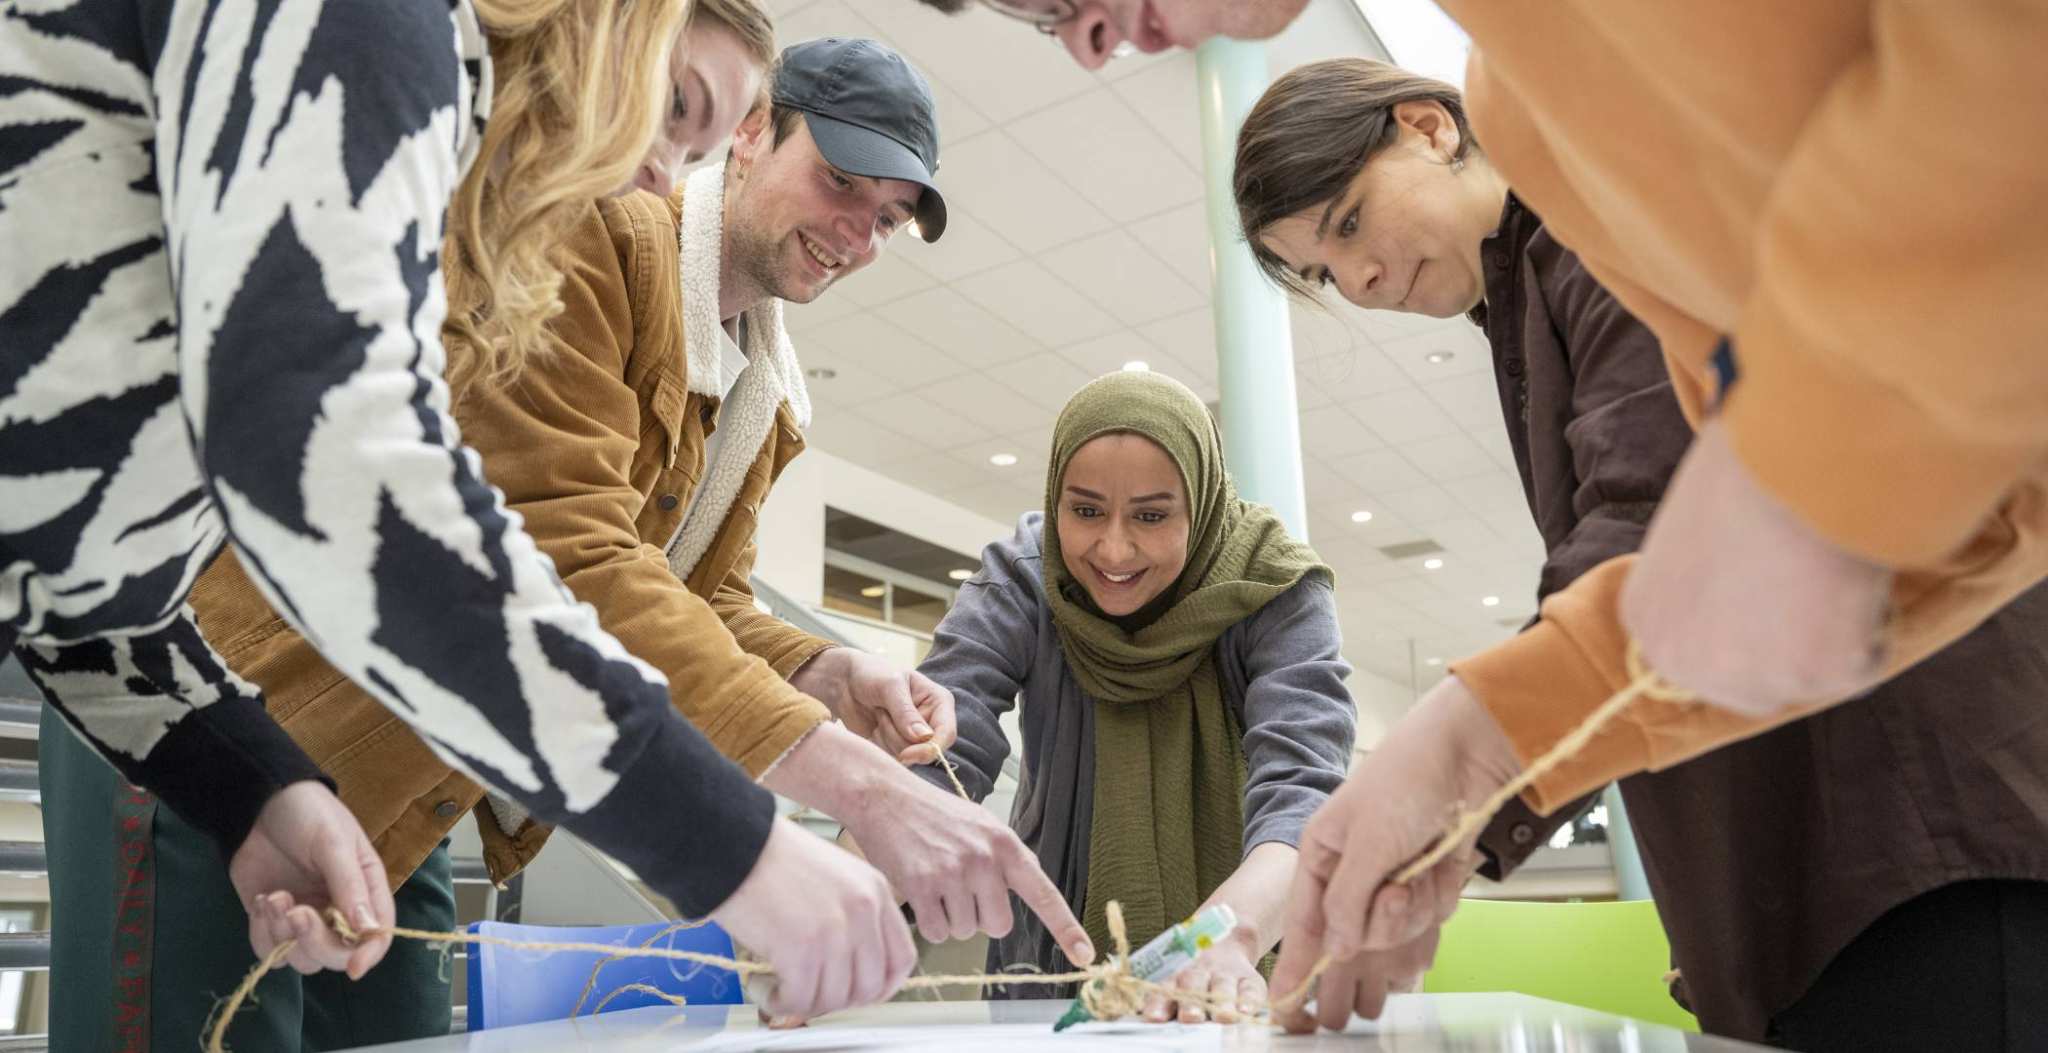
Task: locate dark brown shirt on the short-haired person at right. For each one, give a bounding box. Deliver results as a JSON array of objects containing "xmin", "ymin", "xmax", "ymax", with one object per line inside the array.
[{"xmin": 1479, "ymin": 201, "xmax": 2048, "ymax": 1041}]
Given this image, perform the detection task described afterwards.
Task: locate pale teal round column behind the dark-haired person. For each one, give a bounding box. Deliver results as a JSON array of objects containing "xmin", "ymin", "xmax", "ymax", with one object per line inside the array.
[{"xmin": 1194, "ymin": 37, "xmax": 1309, "ymax": 541}]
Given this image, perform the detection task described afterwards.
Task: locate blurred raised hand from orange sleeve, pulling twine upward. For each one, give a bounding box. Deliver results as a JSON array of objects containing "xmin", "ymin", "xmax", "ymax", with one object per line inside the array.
[{"xmin": 1622, "ymin": 420, "xmax": 1892, "ymax": 717}]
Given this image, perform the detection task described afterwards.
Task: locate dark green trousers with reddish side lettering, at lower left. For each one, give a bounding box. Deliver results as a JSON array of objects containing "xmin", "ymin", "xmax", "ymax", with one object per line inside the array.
[{"xmin": 41, "ymin": 707, "xmax": 455, "ymax": 1053}]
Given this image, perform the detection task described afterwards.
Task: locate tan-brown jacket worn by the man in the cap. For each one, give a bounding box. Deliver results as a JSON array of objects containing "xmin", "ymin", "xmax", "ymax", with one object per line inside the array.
[{"xmin": 190, "ymin": 195, "xmax": 829, "ymax": 887}]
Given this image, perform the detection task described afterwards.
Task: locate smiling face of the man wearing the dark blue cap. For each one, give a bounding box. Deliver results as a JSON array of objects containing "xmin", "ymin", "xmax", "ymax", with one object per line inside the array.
[{"xmin": 721, "ymin": 109, "xmax": 924, "ymax": 303}]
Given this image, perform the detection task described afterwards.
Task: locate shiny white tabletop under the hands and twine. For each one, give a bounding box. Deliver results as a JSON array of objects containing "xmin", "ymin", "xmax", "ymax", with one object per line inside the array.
[{"xmin": 352, "ymin": 994, "xmax": 1765, "ymax": 1053}]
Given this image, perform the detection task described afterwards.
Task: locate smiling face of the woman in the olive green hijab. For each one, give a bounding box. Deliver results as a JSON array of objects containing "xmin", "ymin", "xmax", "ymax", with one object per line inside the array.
[{"xmin": 1057, "ymin": 432, "xmax": 1188, "ymax": 617}]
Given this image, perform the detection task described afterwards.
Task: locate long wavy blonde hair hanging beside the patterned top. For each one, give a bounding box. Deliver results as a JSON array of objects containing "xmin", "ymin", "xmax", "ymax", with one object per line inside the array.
[{"xmin": 442, "ymin": 0, "xmax": 696, "ymax": 381}]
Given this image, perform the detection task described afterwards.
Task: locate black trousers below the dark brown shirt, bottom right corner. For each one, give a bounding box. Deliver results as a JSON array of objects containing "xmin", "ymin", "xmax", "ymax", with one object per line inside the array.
[{"xmin": 1769, "ymin": 881, "xmax": 2048, "ymax": 1053}]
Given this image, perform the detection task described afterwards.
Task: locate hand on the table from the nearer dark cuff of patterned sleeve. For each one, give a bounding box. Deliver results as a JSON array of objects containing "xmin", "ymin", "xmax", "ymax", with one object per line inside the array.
[{"xmin": 711, "ymin": 819, "xmax": 918, "ymax": 1024}]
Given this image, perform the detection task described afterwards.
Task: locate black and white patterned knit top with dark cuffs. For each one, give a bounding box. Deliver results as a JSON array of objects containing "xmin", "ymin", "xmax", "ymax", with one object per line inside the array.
[{"xmin": 0, "ymin": 0, "xmax": 772, "ymax": 914}]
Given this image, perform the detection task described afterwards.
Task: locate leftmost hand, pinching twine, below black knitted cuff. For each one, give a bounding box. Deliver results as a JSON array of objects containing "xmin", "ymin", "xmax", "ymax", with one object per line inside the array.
[{"xmin": 227, "ymin": 781, "xmax": 397, "ymax": 979}]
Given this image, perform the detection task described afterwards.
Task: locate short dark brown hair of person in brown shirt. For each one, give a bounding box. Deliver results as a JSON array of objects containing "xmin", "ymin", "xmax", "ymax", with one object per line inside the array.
[{"xmin": 1231, "ymin": 59, "xmax": 1479, "ymax": 299}]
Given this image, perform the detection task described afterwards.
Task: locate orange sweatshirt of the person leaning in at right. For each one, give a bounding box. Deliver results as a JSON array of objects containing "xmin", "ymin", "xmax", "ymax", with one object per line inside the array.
[{"xmin": 1444, "ymin": 0, "xmax": 2048, "ymax": 811}]
